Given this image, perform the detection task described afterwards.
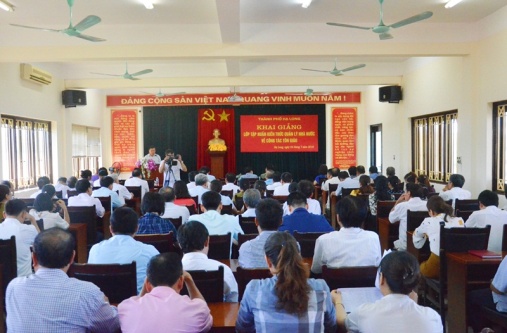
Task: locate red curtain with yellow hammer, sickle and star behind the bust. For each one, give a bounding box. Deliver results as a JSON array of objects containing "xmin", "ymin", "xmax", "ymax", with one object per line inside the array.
[{"xmin": 197, "ymin": 108, "xmax": 236, "ymax": 173}]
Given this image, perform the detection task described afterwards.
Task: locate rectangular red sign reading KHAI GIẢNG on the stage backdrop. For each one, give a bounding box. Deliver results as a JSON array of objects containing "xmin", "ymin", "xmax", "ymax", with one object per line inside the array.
[{"xmin": 240, "ymin": 115, "xmax": 319, "ymax": 153}]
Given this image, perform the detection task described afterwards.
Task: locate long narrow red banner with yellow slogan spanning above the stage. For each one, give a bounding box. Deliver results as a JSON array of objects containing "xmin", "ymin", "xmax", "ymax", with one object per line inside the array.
[{"xmin": 106, "ymin": 92, "xmax": 361, "ymax": 107}]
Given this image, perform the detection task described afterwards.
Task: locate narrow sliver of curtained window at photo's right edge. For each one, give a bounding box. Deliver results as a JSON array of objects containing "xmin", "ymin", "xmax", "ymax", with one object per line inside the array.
[{"xmin": 493, "ymin": 101, "xmax": 507, "ymax": 192}]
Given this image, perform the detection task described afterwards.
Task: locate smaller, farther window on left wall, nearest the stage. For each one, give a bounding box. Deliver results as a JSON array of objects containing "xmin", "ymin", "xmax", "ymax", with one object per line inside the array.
[{"xmin": 72, "ymin": 125, "xmax": 102, "ymax": 177}]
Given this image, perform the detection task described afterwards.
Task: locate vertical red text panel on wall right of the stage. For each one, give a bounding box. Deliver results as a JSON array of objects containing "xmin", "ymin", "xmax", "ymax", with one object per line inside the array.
[{"xmin": 332, "ymin": 108, "xmax": 357, "ymax": 169}]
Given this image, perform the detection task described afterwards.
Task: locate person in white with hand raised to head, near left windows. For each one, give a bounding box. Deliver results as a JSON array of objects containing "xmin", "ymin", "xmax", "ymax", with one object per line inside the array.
[{"xmin": 30, "ymin": 193, "xmax": 70, "ymax": 230}]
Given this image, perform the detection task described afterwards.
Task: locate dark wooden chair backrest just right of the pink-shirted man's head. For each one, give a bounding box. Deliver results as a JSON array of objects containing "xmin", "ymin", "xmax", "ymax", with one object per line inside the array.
[{"xmin": 181, "ymin": 266, "xmax": 224, "ymax": 303}]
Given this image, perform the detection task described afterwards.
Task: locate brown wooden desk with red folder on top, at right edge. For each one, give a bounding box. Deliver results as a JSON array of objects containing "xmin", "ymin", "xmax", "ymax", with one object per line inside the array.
[{"xmin": 447, "ymin": 252, "xmax": 507, "ymax": 332}]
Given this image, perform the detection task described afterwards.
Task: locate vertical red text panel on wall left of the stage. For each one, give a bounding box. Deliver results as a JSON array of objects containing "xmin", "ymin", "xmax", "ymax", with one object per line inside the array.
[{"xmin": 111, "ymin": 110, "xmax": 138, "ymax": 172}]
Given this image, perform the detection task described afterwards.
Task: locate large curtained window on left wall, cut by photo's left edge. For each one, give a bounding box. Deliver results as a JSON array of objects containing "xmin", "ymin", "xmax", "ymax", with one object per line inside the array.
[{"xmin": 0, "ymin": 115, "xmax": 53, "ymax": 190}]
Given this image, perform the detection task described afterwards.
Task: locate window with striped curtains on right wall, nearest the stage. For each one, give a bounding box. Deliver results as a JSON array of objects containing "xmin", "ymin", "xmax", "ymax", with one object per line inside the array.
[{"xmin": 412, "ymin": 110, "xmax": 458, "ymax": 183}]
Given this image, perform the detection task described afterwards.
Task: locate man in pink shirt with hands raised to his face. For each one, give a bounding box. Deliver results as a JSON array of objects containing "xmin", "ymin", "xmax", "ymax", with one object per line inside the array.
[{"xmin": 118, "ymin": 252, "xmax": 213, "ymax": 333}]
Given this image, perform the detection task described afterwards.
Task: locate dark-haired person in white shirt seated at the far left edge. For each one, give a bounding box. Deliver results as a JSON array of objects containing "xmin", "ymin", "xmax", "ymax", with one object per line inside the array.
[{"xmin": 0, "ymin": 199, "xmax": 40, "ymax": 276}]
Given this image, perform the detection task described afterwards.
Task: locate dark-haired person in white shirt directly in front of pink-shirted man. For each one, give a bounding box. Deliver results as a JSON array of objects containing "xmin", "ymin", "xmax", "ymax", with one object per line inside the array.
[{"xmin": 178, "ymin": 220, "xmax": 238, "ymax": 302}]
